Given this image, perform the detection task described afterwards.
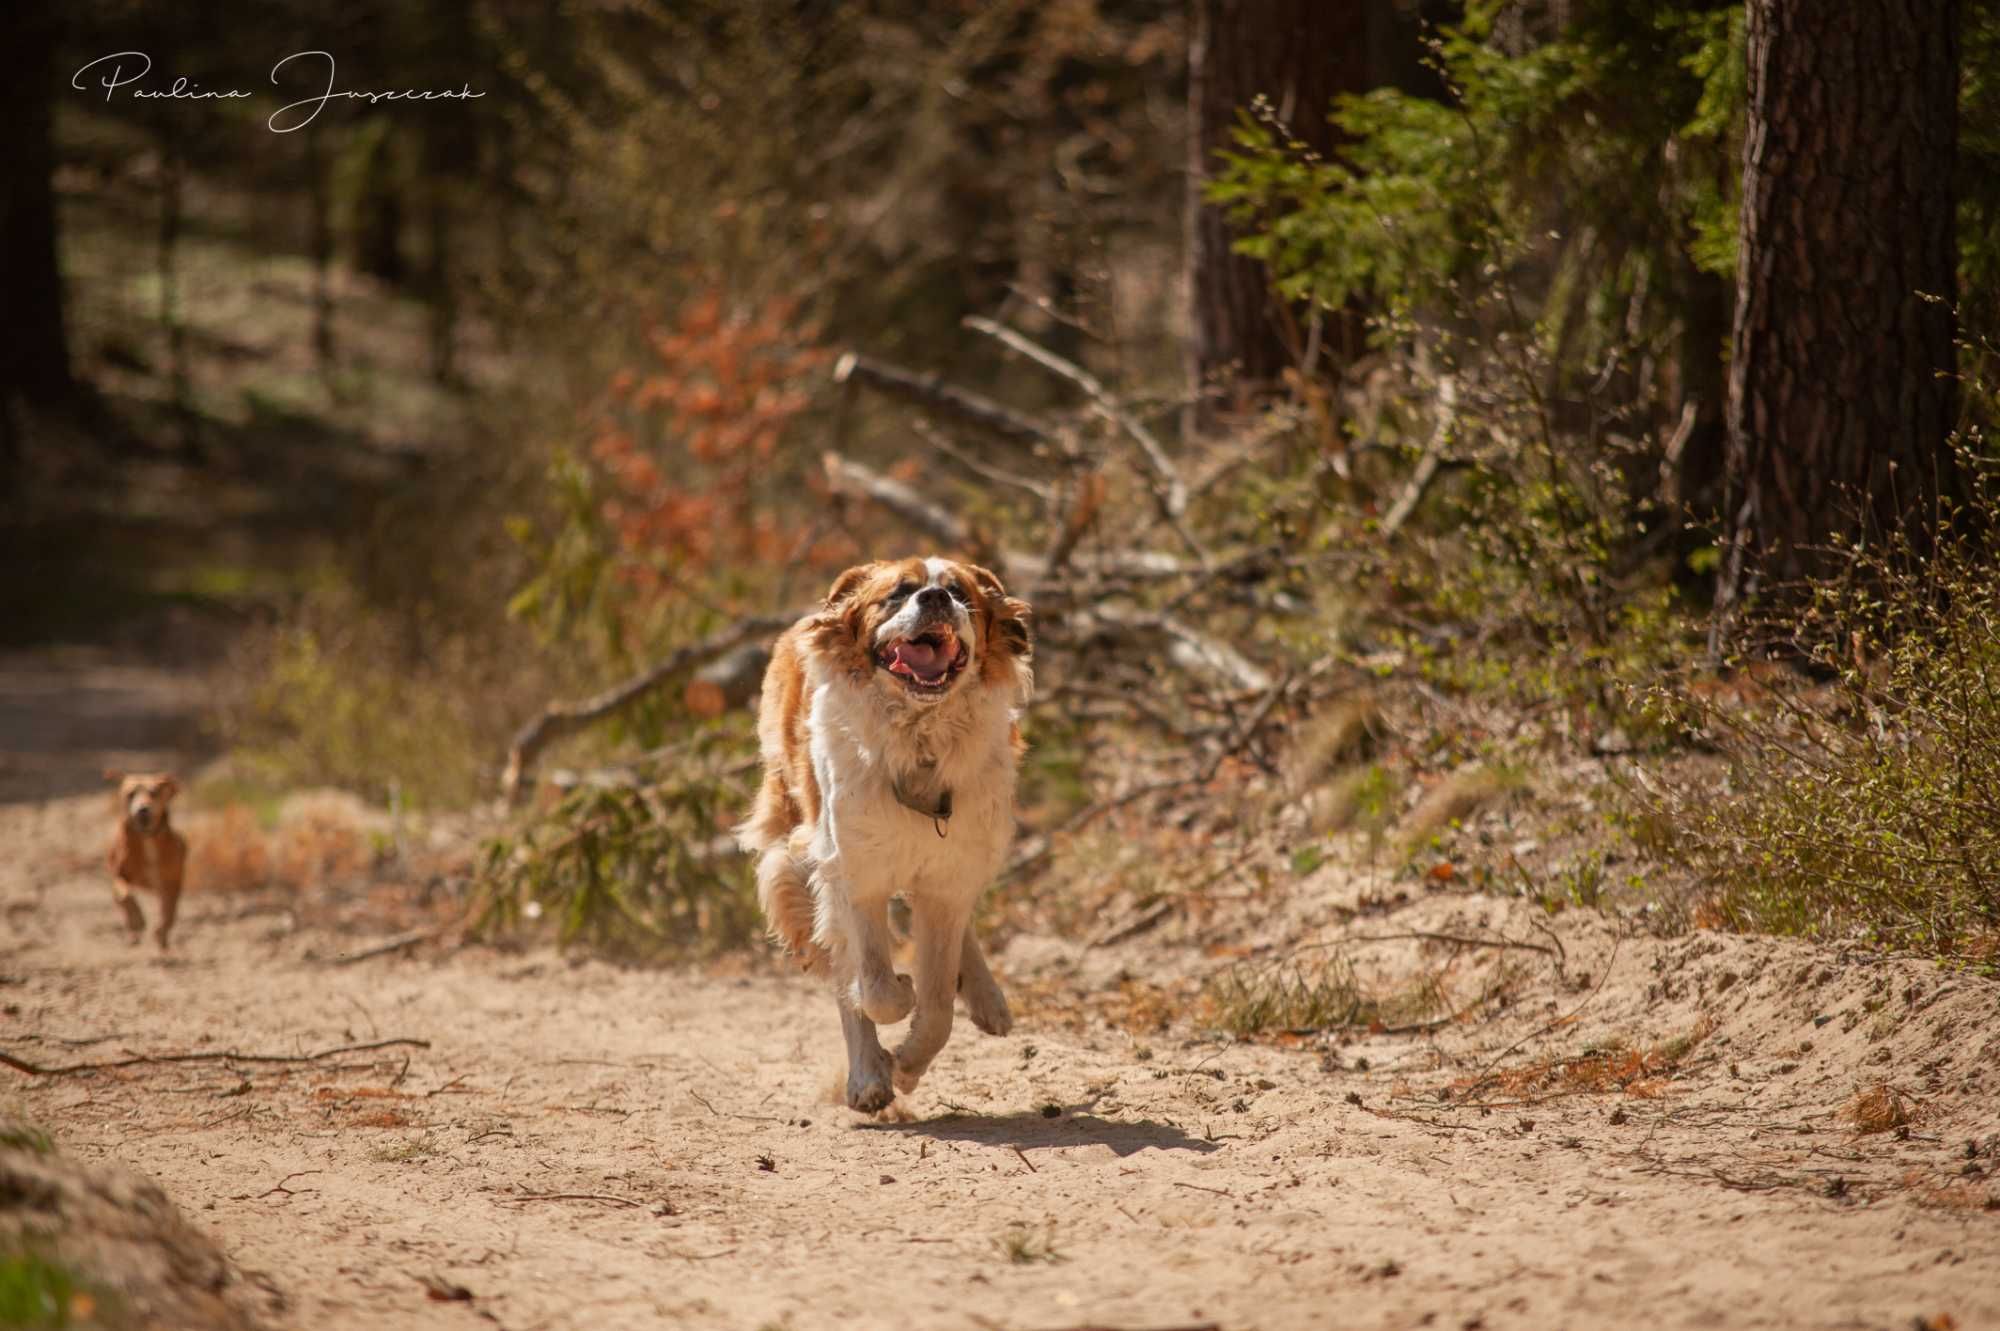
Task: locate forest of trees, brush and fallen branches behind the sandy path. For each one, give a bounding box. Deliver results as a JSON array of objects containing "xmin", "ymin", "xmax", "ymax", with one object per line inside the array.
[{"xmin": 0, "ymin": 0, "xmax": 2000, "ymax": 965}]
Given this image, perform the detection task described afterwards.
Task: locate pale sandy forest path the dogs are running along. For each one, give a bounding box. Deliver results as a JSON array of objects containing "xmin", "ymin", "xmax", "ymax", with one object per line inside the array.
[{"xmin": 0, "ymin": 659, "xmax": 2000, "ymax": 1331}]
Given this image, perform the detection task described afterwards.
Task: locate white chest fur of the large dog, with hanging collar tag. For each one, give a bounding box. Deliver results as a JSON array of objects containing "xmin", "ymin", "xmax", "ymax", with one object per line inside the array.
[{"xmin": 808, "ymin": 659, "xmax": 1014, "ymax": 899}]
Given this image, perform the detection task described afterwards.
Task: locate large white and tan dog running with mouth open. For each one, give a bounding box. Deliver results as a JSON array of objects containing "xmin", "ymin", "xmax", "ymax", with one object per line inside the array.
[{"xmin": 738, "ymin": 560, "xmax": 1034, "ymax": 1111}]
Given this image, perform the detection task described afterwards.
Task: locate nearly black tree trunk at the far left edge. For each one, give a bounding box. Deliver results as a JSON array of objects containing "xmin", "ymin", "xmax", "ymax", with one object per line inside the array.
[{"xmin": 0, "ymin": 4, "xmax": 74, "ymax": 402}]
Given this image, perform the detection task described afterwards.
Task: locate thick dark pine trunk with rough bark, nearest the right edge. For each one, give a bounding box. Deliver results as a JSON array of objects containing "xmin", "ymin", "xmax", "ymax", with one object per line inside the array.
[{"xmin": 1720, "ymin": 0, "xmax": 1958, "ymax": 604}]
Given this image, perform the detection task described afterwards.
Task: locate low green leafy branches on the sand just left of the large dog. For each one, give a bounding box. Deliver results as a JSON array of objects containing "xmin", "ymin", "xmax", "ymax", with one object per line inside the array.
[{"xmin": 476, "ymin": 723, "xmax": 760, "ymax": 957}]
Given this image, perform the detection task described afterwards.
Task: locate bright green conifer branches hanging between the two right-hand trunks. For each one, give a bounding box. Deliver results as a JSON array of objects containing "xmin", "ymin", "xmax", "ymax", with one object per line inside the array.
[{"xmin": 1210, "ymin": 0, "xmax": 1744, "ymax": 338}]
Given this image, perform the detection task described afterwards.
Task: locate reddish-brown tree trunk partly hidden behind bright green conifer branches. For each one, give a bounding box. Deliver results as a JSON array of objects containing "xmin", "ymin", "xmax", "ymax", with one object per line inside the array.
[{"xmin": 1188, "ymin": 0, "xmax": 1386, "ymax": 417}]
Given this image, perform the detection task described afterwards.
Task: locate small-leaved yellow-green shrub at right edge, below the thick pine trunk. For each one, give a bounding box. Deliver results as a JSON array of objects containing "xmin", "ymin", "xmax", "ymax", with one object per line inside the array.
[{"xmin": 1652, "ymin": 448, "xmax": 2000, "ymax": 959}]
